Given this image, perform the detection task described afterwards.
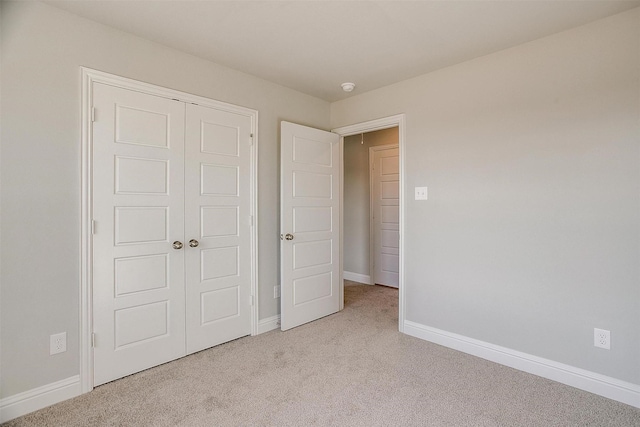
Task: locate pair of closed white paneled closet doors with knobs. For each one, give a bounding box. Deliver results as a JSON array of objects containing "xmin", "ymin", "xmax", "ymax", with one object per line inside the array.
[{"xmin": 92, "ymin": 83, "xmax": 253, "ymax": 385}]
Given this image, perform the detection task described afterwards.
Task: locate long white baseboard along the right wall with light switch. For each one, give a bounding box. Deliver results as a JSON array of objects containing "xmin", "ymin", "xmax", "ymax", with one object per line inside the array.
[{"xmin": 404, "ymin": 320, "xmax": 640, "ymax": 408}]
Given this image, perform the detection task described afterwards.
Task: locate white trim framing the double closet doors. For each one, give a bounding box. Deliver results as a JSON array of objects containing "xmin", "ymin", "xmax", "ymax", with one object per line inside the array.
[{"xmin": 79, "ymin": 67, "xmax": 258, "ymax": 393}]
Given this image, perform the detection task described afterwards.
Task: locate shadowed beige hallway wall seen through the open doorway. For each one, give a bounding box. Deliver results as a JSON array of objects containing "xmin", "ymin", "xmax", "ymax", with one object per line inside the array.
[{"xmin": 343, "ymin": 127, "xmax": 398, "ymax": 276}]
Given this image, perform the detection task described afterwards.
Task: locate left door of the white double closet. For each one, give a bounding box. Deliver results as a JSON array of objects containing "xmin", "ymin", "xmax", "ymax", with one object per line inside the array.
[{"xmin": 92, "ymin": 83, "xmax": 185, "ymax": 385}]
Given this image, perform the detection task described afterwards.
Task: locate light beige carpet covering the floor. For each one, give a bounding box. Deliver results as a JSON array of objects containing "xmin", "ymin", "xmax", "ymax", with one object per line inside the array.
[{"xmin": 7, "ymin": 284, "xmax": 640, "ymax": 426}]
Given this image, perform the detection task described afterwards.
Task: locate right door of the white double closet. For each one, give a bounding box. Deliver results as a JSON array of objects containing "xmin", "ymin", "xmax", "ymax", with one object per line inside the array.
[{"xmin": 185, "ymin": 105, "xmax": 252, "ymax": 353}]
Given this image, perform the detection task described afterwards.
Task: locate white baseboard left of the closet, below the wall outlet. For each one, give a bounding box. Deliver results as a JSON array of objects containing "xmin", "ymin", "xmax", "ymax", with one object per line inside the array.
[{"xmin": 0, "ymin": 375, "xmax": 82, "ymax": 423}]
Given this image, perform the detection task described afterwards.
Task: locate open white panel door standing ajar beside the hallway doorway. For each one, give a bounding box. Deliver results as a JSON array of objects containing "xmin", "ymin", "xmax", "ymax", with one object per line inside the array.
[{"xmin": 280, "ymin": 122, "xmax": 341, "ymax": 330}]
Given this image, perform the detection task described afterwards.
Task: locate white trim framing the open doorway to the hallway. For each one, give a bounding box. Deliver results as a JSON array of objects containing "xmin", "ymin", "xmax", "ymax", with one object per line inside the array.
[{"xmin": 332, "ymin": 114, "xmax": 405, "ymax": 332}]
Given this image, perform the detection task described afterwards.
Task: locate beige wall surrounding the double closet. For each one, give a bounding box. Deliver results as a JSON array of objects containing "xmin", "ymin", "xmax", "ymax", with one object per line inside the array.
[{"xmin": 0, "ymin": 2, "xmax": 329, "ymax": 398}]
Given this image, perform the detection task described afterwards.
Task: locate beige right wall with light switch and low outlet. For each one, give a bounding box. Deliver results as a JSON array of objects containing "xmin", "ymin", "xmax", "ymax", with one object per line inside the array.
[{"xmin": 331, "ymin": 9, "xmax": 640, "ymax": 384}]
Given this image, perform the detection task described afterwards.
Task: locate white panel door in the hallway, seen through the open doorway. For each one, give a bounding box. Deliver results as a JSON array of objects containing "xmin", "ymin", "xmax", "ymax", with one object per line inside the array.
[{"xmin": 369, "ymin": 147, "xmax": 400, "ymax": 288}]
